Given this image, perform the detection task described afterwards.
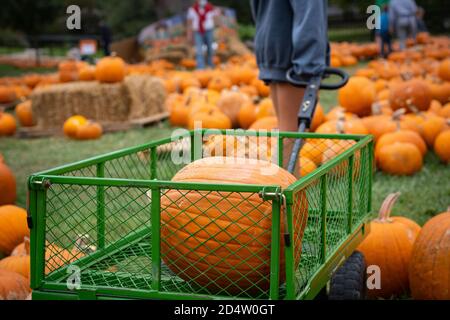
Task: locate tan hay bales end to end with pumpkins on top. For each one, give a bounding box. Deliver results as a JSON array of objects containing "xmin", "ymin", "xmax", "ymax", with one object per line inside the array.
[{"xmin": 31, "ymin": 75, "xmax": 166, "ymax": 129}]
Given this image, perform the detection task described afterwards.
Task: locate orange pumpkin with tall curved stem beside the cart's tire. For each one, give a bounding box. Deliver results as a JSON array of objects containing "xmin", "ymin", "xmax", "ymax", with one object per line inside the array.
[{"xmin": 358, "ymin": 193, "xmax": 420, "ymax": 299}]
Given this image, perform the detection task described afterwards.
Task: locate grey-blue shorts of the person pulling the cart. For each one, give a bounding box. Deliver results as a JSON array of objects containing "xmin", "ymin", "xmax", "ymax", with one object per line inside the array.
[{"xmin": 251, "ymin": 0, "xmax": 329, "ymax": 82}]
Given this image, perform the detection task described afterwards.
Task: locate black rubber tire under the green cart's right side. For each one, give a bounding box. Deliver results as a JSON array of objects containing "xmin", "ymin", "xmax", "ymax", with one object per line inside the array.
[{"xmin": 328, "ymin": 251, "xmax": 367, "ymax": 300}]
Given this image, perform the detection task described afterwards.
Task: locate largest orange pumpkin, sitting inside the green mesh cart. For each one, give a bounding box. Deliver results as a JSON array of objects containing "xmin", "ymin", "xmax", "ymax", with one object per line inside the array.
[{"xmin": 161, "ymin": 157, "xmax": 308, "ymax": 294}]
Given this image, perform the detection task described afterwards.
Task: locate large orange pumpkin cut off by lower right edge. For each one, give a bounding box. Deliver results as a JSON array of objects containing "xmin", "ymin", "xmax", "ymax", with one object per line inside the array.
[{"xmin": 409, "ymin": 208, "xmax": 450, "ymax": 300}]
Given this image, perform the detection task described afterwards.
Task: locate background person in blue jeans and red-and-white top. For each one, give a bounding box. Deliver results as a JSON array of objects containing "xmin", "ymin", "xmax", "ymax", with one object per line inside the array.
[{"xmin": 187, "ymin": 0, "xmax": 216, "ymax": 69}]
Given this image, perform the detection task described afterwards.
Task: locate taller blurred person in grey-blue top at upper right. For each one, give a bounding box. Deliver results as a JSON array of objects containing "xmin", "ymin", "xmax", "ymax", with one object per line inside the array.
[{"xmin": 389, "ymin": 0, "xmax": 417, "ymax": 50}]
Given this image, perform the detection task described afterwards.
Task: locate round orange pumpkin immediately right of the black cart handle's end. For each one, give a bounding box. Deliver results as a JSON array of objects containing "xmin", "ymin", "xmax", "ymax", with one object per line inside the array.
[{"xmin": 338, "ymin": 77, "xmax": 376, "ymax": 116}]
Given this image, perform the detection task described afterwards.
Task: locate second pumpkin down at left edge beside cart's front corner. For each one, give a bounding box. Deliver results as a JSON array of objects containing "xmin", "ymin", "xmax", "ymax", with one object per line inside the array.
[{"xmin": 0, "ymin": 205, "xmax": 30, "ymax": 255}]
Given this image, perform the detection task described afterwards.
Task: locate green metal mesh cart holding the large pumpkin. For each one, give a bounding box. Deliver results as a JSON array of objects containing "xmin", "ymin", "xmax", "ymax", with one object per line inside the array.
[{"xmin": 28, "ymin": 130, "xmax": 373, "ymax": 299}]
